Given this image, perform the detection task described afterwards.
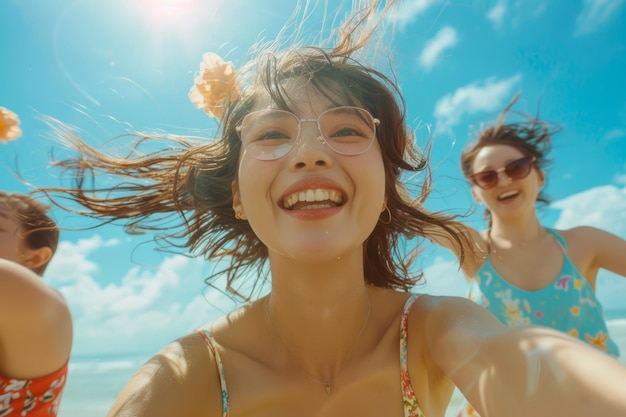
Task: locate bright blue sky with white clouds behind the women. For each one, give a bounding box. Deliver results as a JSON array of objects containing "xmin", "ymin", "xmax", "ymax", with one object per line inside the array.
[{"xmin": 0, "ymin": 0, "xmax": 626, "ymax": 355}]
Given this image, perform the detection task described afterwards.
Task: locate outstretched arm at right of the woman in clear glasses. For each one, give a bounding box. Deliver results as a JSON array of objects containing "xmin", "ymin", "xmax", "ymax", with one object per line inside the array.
[{"xmin": 424, "ymin": 297, "xmax": 626, "ymax": 417}]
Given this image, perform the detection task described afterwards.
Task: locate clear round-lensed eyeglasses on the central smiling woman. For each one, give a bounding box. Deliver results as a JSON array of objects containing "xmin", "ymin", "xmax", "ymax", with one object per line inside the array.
[{"xmin": 237, "ymin": 106, "xmax": 380, "ymax": 161}]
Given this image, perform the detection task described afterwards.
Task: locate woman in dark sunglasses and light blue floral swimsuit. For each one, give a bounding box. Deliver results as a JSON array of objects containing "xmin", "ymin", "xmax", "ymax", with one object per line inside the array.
[{"xmin": 440, "ymin": 100, "xmax": 626, "ymax": 416}]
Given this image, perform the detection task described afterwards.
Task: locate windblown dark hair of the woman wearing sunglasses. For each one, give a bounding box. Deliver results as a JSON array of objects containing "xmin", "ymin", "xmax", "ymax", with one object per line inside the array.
[{"xmin": 461, "ymin": 94, "xmax": 560, "ymax": 226}]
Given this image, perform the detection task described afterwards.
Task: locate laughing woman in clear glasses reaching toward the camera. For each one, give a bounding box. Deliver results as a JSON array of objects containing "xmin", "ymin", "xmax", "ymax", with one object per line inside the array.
[{"xmin": 29, "ymin": 1, "xmax": 626, "ymax": 417}]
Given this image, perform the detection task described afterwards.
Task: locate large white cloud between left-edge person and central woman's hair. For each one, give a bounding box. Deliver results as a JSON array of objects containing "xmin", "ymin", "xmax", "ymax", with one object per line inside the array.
[{"xmin": 46, "ymin": 235, "xmax": 237, "ymax": 355}]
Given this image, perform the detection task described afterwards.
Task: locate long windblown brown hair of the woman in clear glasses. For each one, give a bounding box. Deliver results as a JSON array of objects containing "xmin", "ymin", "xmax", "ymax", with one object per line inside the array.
[{"xmin": 45, "ymin": 1, "xmax": 462, "ymax": 299}]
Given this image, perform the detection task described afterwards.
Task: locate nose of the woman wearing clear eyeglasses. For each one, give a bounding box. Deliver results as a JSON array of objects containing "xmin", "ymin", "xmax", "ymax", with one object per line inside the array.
[{"xmin": 290, "ymin": 123, "xmax": 332, "ymax": 169}]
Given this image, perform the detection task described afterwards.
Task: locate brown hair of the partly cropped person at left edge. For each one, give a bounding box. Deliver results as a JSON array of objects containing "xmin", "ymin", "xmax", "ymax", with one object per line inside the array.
[{"xmin": 0, "ymin": 191, "xmax": 59, "ymax": 275}]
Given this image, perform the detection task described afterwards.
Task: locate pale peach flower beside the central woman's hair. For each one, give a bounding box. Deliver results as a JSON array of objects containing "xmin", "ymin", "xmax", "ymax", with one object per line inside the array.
[{"xmin": 189, "ymin": 52, "xmax": 240, "ymax": 119}]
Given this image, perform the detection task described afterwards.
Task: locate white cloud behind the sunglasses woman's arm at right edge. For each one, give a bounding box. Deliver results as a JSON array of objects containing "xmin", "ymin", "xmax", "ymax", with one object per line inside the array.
[{"xmin": 552, "ymin": 185, "xmax": 626, "ymax": 309}]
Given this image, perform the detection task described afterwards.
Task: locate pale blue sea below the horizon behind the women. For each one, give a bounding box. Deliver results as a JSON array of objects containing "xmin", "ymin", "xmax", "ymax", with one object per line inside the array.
[{"xmin": 59, "ymin": 310, "xmax": 626, "ymax": 417}]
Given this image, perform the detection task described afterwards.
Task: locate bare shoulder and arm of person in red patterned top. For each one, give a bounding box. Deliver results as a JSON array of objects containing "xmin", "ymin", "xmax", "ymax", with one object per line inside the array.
[{"xmin": 0, "ymin": 259, "xmax": 72, "ymax": 379}]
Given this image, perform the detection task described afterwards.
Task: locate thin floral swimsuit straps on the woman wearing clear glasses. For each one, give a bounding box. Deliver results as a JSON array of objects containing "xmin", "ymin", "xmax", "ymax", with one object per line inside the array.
[{"xmin": 199, "ymin": 294, "xmax": 424, "ymax": 417}]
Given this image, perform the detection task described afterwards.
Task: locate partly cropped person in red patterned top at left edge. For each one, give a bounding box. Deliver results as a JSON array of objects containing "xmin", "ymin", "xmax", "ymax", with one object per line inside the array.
[{"xmin": 0, "ymin": 191, "xmax": 72, "ymax": 417}]
